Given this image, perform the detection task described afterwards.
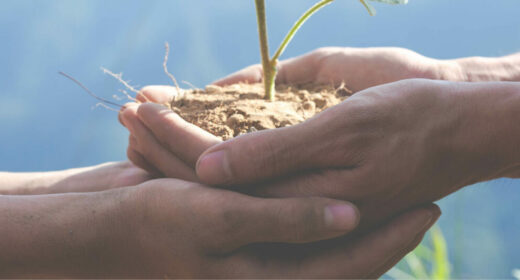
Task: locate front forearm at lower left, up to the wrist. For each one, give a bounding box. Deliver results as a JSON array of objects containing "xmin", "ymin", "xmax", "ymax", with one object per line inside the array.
[{"xmin": 0, "ymin": 189, "xmax": 134, "ymax": 277}]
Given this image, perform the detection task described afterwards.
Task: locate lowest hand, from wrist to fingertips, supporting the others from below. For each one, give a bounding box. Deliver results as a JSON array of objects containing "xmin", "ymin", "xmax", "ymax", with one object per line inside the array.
[{"xmin": 112, "ymin": 179, "xmax": 440, "ymax": 278}]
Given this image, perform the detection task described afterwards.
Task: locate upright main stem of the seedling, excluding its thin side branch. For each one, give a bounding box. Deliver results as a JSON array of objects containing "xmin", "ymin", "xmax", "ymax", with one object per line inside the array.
[{"xmin": 255, "ymin": 0, "xmax": 276, "ymax": 101}]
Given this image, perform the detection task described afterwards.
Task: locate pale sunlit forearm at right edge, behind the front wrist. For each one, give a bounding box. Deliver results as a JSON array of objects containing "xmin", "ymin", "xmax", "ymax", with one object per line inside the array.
[{"xmin": 438, "ymin": 53, "xmax": 520, "ymax": 82}]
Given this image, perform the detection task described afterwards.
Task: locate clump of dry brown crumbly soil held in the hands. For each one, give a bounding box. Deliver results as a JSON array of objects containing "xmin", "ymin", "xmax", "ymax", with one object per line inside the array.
[{"xmin": 170, "ymin": 84, "xmax": 352, "ymax": 140}]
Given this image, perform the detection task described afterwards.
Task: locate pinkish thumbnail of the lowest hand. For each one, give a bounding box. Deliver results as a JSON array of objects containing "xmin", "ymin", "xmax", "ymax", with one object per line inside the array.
[{"xmin": 325, "ymin": 204, "xmax": 359, "ymax": 231}]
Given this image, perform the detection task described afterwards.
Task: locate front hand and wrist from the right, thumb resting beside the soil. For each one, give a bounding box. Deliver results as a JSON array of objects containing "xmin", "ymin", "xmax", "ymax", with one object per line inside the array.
[{"xmin": 196, "ymin": 80, "xmax": 520, "ymax": 229}]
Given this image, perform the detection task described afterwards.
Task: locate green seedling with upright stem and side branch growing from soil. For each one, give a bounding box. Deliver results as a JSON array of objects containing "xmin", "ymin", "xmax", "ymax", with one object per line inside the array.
[{"xmin": 255, "ymin": 0, "xmax": 408, "ymax": 101}]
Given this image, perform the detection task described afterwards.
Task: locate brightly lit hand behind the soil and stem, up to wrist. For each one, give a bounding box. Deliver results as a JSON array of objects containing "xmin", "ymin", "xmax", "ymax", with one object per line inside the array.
[{"xmin": 214, "ymin": 47, "xmax": 450, "ymax": 92}]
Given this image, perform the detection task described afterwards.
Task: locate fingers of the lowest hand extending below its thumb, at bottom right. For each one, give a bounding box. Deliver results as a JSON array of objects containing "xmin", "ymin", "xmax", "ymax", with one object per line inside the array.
[{"xmin": 300, "ymin": 205, "xmax": 440, "ymax": 279}]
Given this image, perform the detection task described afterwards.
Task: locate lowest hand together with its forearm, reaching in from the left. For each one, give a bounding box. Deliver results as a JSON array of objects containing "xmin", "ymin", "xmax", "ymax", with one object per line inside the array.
[{"xmin": 0, "ymin": 175, "xmax": 440, "ymax": 278}]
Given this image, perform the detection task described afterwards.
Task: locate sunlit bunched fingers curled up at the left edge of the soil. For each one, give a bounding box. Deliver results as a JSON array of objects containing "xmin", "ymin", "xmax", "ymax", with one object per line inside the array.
[{"xmin": 119, "ymin": 86, "xmax": 222, "ymax": 182}]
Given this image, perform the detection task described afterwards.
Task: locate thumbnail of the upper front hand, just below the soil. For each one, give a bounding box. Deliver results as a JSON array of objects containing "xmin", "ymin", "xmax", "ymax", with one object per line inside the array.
[{"xmin": 197, "ymin": 150, "xmax": 232, "ymax": 185}]
